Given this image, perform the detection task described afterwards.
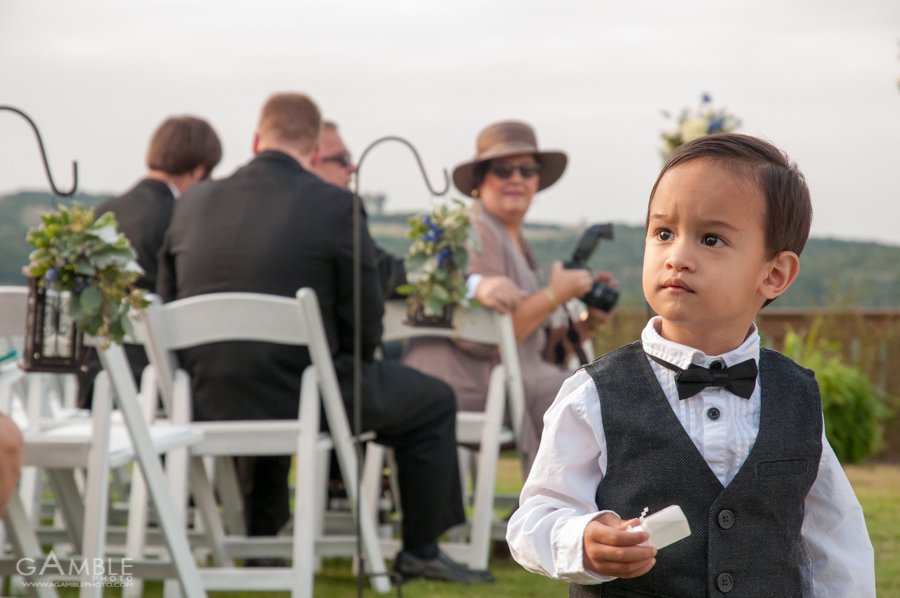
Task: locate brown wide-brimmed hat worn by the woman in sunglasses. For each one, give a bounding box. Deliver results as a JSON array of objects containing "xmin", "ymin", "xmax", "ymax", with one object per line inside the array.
[{"xmin": 453, "ymin": 121, "xmax": 568, "ymax": 195}]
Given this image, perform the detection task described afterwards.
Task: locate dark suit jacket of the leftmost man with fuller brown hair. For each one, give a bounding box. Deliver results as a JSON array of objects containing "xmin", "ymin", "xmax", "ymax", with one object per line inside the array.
[{"xmin": 96, "ymin": 179, "xmax": 175, "ymax": 292}]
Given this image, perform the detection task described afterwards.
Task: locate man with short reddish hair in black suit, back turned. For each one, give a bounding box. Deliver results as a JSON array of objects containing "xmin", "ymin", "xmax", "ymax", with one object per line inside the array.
[{"xmin": 156, "ymin": 94, "xmax": 493, "ymax": 583}]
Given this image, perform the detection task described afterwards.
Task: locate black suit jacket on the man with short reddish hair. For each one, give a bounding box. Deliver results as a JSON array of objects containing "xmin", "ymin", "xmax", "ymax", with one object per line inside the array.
[{"xmin": 157, "ymin": 151, "xmax": 384, "ymax": 419}]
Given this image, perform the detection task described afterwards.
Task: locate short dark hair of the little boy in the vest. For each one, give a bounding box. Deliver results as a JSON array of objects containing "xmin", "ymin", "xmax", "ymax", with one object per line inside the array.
[{"xmin": 647, "ymin": 133, "xmax": 812, "ymax": 262}]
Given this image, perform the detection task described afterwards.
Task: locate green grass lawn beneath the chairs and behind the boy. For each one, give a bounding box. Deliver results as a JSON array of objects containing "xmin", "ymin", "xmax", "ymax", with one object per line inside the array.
[{"xmin": 44, "ymin": 458, "xmax": 900, "ymax": 598}]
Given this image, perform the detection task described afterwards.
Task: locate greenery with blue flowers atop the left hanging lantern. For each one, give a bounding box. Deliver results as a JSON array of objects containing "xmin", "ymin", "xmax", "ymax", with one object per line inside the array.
[{"xmin": 22, "ymin": 203, "xmax": 149, "ymax": 350}]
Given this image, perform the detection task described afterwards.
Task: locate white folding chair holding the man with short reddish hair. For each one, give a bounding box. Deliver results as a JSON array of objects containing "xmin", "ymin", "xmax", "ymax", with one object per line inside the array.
[{"xmin": 139, "ymin": 289, "xmax": 390, "ymax": 598}]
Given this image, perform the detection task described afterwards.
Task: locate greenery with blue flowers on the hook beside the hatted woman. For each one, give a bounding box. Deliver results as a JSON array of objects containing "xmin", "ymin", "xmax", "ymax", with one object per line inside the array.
[{"xmin": 397, "ymin": 201, "xmax": 479, "ymax": 316}]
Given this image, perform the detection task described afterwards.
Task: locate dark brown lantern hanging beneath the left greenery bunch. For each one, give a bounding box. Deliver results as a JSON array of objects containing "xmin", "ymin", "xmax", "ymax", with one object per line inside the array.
[{"xmin": 22, "ymin": 278, "xmax": 85, "ymax": 374}]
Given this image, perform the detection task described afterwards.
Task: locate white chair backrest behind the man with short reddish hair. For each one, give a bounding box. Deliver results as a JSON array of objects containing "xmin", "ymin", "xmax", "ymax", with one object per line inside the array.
[{"xmin": 135, "ymin": 289, "xmax": 337, "ymax": 422}]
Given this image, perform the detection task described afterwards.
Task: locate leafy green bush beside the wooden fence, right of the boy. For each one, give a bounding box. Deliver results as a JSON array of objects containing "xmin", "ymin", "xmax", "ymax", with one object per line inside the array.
[{"xmin": 784, "ymin": 318, "xmax": 888, "ymax": 463}]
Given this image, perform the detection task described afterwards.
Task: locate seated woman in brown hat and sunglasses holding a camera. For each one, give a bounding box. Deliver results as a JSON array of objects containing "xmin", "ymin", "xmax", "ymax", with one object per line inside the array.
[{"xmin": 404, "ymin": 122, "xmax": 614, "ymax": 474}]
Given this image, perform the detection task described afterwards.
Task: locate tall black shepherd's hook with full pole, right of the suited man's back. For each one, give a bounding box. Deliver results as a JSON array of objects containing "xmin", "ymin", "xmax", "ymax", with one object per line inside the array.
[{"xmin": 352, "ymin": 136, "xmax": 450, "ymax": 598}]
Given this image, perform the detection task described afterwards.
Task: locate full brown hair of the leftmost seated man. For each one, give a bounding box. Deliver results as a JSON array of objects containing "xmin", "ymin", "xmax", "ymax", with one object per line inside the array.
[{"xmin": 147, "ymin": 116, "xmax": 222, "ymax": 176}]
